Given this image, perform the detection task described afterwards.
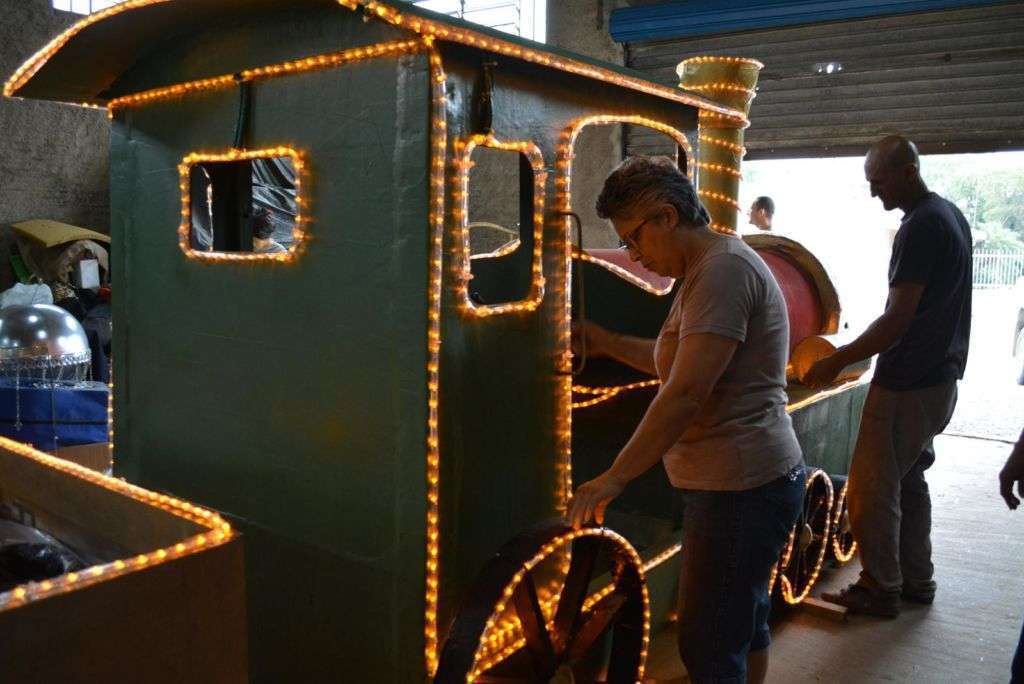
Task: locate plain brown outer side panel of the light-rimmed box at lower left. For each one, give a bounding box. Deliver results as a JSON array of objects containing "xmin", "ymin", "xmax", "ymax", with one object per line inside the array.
[{"xmin": 0, "ymin": 540, "xmax": 248, "ymax": 684}]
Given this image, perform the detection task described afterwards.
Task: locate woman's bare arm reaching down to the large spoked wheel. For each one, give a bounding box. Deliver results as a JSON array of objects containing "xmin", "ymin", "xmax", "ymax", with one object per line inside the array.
[{"xmin": 566, "ymin": 333, "xmax": 738, "ymax": 527}]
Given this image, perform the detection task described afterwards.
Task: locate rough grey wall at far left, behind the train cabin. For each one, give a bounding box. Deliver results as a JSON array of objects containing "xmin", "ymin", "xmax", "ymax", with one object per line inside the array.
[{"xmin": 0, "ymin": 0, "xmax": 110, "ymax": 289}]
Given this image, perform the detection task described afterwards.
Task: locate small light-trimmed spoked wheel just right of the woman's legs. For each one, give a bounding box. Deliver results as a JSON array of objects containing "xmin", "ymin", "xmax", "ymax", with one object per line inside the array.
[{"xmin": 779, "ymin": 469, "xmax": 833, "ymax": 604}]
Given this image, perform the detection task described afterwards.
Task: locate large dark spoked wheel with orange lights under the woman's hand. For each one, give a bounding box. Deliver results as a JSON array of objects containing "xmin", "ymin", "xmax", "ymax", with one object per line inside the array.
[{"xmin": 434, "ymin": 521, "xmax": 650, "ymax": 684}]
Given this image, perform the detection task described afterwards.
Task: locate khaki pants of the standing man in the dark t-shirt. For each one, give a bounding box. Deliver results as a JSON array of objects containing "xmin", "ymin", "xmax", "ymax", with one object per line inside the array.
[{"xmin": 848, "ymin": 380, "xmax": 956, "ymax": 594}]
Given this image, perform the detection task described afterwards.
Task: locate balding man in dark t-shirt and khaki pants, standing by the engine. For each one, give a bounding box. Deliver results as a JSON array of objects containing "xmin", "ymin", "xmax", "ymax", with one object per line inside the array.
[{"xmin": 804, "ymin": 135, "xmax": 973, "ymax": 617}]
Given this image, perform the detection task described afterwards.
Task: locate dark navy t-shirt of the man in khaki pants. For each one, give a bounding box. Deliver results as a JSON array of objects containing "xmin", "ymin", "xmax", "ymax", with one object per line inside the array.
[{"xmin": 872, "ymin": 193, "xmax": 973, "ymax": 390}]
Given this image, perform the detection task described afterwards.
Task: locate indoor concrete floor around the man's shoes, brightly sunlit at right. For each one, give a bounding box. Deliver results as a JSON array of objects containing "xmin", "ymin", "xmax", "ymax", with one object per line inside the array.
[{"xmin": 647, "ymin": 436, "xmax": 1024, "ymax": 684}]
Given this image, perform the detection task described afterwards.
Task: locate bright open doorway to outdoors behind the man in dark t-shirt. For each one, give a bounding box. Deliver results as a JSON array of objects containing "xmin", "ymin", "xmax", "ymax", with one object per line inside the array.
[{"xmin": 740, "ymin": 152, "xmax": 1024, "ymax": 441}]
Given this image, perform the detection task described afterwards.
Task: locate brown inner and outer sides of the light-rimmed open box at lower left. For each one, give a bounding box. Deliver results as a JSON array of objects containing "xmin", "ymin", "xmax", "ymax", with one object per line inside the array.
[{"xmin": 0, "ymin": 440, "xmax": 248, "ymax": 683}]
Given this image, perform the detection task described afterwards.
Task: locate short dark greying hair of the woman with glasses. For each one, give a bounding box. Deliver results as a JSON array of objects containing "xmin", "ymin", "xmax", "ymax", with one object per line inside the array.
[{"xmin": 596, "ymin": 157, "xmax": 711, "ymax": 227}]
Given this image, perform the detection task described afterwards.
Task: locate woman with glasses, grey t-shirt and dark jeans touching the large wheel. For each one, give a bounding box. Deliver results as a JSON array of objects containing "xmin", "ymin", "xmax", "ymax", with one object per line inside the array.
[{"xmin": 567, "ymin": 157, "xmax": 805, "ymax": 684}]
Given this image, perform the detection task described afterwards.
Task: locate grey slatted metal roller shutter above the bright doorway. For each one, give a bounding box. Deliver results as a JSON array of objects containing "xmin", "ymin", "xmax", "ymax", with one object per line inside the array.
[{"xmin": 627, "ymin": 2, "xmax": 1024, "ymax": 159}]
